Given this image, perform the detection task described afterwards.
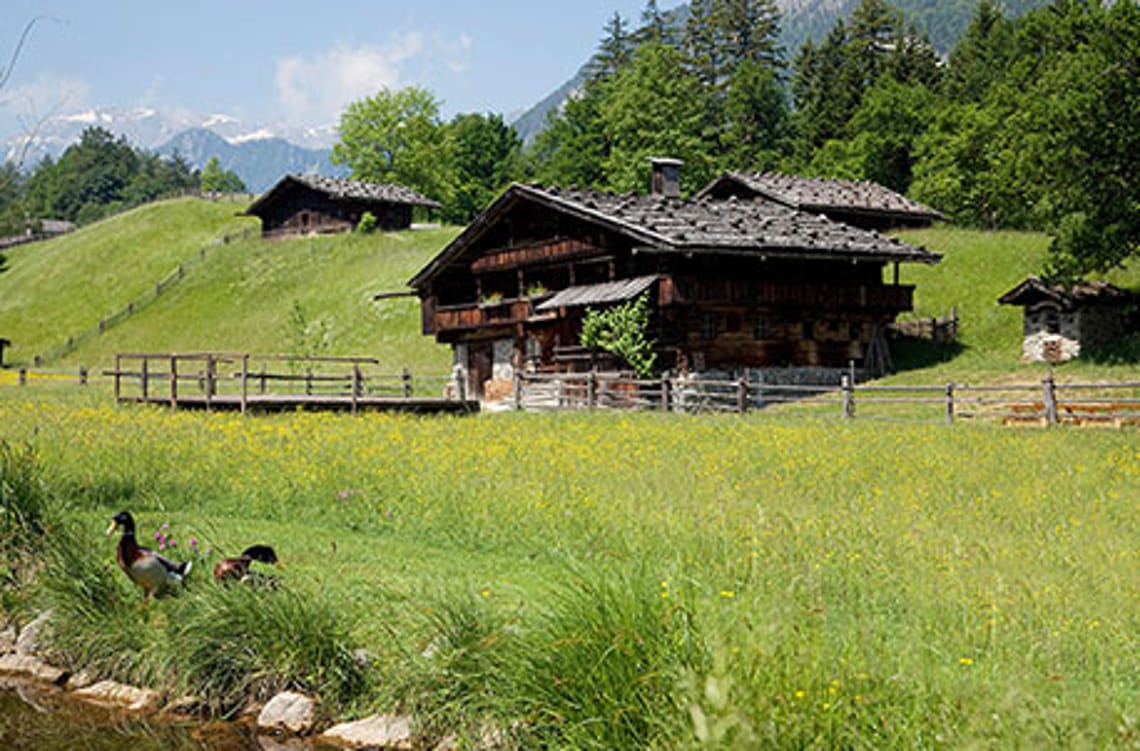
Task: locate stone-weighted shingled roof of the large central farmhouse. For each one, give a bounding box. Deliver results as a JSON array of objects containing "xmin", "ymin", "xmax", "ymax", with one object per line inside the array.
[{"xmin": 408, "ymin": 183, "xmax": 942, "ymax": 287}]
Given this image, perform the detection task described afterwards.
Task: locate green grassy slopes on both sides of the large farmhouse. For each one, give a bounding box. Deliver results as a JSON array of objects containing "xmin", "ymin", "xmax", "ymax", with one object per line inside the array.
[{"xmin": 0, "ymin": 199, "xmax": 1140, "ymax": 383}]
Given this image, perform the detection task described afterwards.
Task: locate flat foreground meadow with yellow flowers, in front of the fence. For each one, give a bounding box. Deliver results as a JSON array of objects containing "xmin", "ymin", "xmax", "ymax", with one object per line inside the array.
[{"xmin": 0, "ymin": 395, "xmax": 1140, "ymax": 749}]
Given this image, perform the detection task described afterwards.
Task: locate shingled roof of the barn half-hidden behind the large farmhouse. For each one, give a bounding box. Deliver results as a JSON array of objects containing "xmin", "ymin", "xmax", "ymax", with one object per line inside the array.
[{"xmin": 697, "ymin": 172, "xmax": 943, "ymax": 221}]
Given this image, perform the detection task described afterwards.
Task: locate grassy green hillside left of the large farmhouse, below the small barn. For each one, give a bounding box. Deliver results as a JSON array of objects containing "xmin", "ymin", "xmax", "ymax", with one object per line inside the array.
[{"xmin": 0, "ymin": 199, "xmax": 456, "ymax": 374}]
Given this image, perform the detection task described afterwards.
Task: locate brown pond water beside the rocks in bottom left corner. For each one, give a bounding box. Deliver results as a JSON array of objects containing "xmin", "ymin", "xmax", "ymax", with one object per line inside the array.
[{"xmin": 0, "ymin": 678, "xmax": 316, "ymax": 751}]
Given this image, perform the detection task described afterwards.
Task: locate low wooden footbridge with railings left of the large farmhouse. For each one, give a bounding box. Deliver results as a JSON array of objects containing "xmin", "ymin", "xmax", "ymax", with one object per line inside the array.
[{"xmin": 104, "ymin": 352, "xmax": 479, "ymax": 414}]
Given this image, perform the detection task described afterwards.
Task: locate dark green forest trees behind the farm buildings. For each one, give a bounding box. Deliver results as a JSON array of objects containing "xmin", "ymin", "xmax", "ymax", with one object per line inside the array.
[{"xmin": 0, "ymin": 0, "xmax": 1140, "ymax": 278}]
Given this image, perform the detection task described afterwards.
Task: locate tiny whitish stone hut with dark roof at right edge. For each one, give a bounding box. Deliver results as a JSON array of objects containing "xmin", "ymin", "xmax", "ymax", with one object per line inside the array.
[{"xmin": 998, "ymin": 277, "xmax": 1137, "ymax": 362}]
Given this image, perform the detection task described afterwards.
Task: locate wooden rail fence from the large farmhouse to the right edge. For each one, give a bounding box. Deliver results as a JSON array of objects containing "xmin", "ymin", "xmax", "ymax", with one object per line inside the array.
[{"xmin": 513, "ymin": 372, "xmax": 1140, "ymax": 426}]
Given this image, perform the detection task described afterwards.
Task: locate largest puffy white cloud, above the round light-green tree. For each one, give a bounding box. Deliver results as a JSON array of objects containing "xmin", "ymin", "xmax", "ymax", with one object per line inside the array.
[{"xmin": 277, "ymin": 32, "xmax": 424, "ymax": 125}]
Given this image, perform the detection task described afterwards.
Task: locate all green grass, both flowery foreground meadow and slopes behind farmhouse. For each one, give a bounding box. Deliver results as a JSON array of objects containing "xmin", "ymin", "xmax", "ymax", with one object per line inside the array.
[{"xmin": 0, "ymin": 201, "xmax": 1140, "ymax": 749}]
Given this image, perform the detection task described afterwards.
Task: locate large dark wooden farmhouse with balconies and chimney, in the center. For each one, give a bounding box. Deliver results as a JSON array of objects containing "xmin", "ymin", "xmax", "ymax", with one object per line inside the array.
[{"xmin": 409, "ymin": 165, "xmax": 939, "ymax": 395}]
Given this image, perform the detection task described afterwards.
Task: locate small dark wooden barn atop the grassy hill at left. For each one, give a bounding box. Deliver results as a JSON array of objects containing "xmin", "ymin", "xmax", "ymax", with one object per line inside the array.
[{"xmin": 245, "ymin": 174, "xmax": 440, "ymax": 237}]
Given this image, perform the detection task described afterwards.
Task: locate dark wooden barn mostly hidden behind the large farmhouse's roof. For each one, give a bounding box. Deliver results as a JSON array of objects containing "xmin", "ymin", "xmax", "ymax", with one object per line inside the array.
[{"xmin": 697, "ymin": 172, "xmax": 943, "ymax": 230}]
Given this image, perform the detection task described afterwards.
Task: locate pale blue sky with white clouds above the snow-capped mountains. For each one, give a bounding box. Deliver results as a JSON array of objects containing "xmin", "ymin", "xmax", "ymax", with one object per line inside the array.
[{"xmin": 0, "ymin": 0, "xmax": 678, "ymax": 140}]
